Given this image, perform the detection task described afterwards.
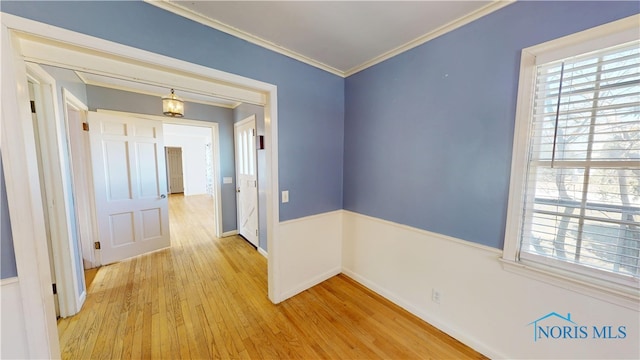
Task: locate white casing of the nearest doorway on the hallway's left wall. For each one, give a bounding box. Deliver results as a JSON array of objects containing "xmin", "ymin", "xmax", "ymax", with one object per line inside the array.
[{"xmin": 26, "ymin": 63, "xmax": 86, "ymax": 317}]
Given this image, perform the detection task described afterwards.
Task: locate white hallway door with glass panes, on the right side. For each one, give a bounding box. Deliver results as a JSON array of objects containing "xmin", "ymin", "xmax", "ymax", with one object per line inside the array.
[{"xmin": 233, "ymin": 116, "xmax": 258, "ymax": 247}]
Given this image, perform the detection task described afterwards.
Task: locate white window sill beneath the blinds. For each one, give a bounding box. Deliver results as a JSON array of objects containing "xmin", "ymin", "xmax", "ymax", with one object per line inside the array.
[{"xmin": 500, "ymin": 258, "xmax": 640, "ymax": 311}]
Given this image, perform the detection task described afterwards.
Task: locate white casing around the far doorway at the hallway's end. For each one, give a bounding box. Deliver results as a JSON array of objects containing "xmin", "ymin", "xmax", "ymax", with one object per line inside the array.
[{"xmin": 96, "ymin": 109, "xmax": 225, "ymax": 237}]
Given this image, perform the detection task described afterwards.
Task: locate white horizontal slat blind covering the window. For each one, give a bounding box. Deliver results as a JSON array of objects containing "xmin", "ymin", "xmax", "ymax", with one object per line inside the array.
[{"xmin": 518, "ymin": 41, "xmax": 640, "ymax": 287}]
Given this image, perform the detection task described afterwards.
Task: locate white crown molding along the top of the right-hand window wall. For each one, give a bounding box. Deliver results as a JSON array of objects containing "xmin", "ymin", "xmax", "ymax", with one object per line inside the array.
[{"xmin": 344, "ymin": 0, "xmax": 516, "ymax": 77}]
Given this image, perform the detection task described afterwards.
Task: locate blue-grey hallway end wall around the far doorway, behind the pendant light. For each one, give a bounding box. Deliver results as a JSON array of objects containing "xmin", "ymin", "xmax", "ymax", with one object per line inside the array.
[{"xmin": 87, "ymin": 85, "xmax": 236, "ymax": 232}]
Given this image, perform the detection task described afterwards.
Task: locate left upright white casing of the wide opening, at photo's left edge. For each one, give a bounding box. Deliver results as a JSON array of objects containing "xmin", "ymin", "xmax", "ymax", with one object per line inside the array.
[{"xmin": 0, "ymin": 21, "xmax": 60, "ymax": 359}]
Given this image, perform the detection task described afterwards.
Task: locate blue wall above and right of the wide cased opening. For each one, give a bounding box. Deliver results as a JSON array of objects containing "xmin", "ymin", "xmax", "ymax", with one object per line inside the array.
[{"xmin": 0, "ymin": 1, "xmax": 344, "ymax": 221}]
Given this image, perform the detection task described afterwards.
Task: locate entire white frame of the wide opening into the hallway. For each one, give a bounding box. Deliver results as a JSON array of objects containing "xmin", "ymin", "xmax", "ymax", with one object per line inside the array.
[{"xmin": 0, "ymin": 13, "xmax": 285, "ymax": 358}]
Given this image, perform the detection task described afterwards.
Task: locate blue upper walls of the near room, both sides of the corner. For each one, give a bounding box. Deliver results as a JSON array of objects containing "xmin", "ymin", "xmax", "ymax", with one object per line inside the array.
[{"xmin": 0, "ymin": 1, "xmax": 640, "ymax": 258}]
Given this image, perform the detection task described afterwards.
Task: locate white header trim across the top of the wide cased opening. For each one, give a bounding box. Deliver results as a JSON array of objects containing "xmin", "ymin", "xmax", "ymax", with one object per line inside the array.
[{"xmin": 1, "ymin": 13, "xmax": 268, "ymax": 105}]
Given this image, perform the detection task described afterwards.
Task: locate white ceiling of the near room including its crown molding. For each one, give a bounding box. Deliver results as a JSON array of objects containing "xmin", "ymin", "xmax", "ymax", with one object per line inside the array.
[{"xmin": 156, "ymin": 0, "xmax": 511, "ymax": 76}]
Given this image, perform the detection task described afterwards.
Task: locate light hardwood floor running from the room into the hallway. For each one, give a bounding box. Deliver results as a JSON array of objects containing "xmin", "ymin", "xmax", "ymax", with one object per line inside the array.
[{"xmin": 58, "ymin": 196, "xmax": 484, "ymax": 359}]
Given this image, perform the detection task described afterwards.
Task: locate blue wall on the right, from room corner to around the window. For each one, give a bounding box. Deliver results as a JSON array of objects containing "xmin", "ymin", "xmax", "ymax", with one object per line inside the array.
[{"xmin": 344, "ymin": 1, "xmax": 640, "ymax": 249}]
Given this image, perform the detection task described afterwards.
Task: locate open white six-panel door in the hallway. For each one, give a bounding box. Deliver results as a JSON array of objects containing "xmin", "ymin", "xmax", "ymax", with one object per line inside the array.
[{"xmin": 89, "ymin": 112, "xmax": 170, "ymax": 264}]
